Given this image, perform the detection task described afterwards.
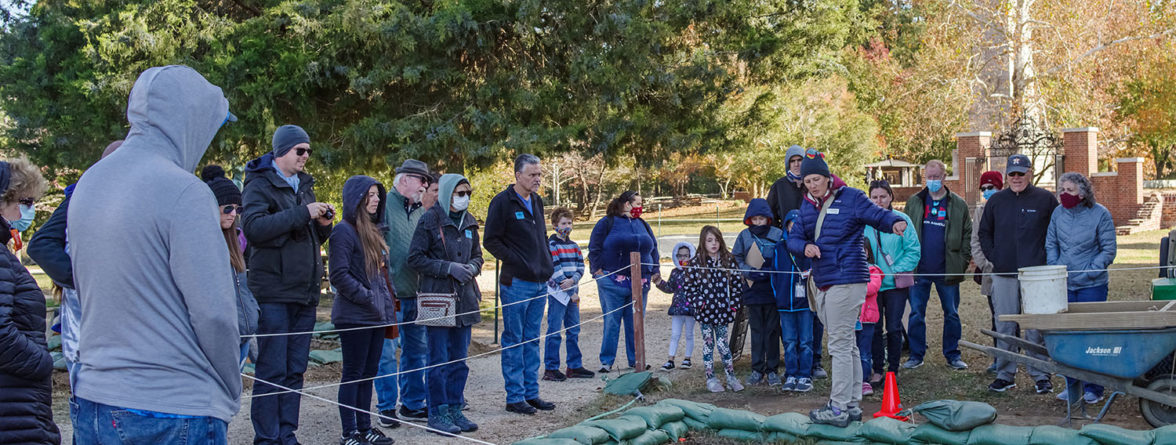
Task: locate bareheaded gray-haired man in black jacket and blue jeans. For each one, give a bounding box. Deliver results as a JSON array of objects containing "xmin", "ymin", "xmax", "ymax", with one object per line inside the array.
[{"xmin": 483, "ymin": 154, "xmax": 555, "ymax": 414}]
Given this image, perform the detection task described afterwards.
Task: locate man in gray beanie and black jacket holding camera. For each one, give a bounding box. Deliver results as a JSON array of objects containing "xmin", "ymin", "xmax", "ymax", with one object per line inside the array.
[{"xmin": 241, "ymin": 125, "xmax": 335, "ymax": 445}]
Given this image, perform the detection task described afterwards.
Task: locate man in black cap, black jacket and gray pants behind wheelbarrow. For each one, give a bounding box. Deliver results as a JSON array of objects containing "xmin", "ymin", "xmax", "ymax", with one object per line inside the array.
[{"xmin": 977, "ymin": 154, "xmax": 1057, "ymax": 394}]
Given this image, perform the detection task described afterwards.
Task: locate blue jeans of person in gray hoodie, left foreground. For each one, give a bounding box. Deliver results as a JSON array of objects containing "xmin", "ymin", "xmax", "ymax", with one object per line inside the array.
[{"xmin": 69, "ymin": 397, "xmax": 228, "ymax": 445}]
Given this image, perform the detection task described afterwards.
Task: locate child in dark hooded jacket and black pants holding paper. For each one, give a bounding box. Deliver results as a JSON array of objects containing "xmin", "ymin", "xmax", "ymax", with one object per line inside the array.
[{"xmin": 731, "ymin": 198, "xmax": 783, "ymax": 386}]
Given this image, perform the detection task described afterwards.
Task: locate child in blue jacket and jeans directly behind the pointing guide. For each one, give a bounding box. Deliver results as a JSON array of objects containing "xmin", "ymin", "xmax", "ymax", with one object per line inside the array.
[{"xmin": 771, "ymin": 211, "xmax": 814, "ymax": 392}]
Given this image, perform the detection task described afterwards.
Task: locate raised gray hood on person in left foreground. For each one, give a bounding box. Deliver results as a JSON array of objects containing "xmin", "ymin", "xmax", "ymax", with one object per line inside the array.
[{"xmin": 123, "ymin": 65, "xmax": 230, "ymax": 172}]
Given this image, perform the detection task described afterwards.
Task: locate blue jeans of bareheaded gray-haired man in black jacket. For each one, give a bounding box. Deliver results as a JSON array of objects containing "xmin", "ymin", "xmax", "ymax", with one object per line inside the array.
[{"xmin": 501, "ymin": 278, "xmax": 547, "ymax": 404}]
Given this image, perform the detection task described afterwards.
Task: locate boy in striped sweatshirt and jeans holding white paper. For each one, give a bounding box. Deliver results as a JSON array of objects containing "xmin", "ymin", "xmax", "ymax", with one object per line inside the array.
[{"xmin": 543, "ymin": 207, "xmax": 596, "ymax": 381}]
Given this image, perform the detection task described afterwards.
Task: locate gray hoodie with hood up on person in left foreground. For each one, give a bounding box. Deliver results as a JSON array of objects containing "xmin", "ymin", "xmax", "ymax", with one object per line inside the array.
[{"xmin": 67, "ymin": 66, "xmax": 241, "ymax": 421}]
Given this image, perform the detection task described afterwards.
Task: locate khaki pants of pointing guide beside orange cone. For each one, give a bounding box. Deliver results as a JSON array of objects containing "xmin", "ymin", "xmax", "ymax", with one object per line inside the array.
[{"xmin": 813, "ymin": 283, "xmax": 866, "ymax": 410}]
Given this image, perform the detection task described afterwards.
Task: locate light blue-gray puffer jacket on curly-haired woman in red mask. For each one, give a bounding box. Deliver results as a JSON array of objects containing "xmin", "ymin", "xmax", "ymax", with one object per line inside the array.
[{"xmin": 1045, "ymin": 204, "xmax": 1116, "ymax": 291}]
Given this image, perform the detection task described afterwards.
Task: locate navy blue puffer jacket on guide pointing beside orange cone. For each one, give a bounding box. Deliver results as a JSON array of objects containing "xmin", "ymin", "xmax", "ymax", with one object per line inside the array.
[{"xmin": 788, "ymin": 181, "xmax": 903, "ymax": 288}]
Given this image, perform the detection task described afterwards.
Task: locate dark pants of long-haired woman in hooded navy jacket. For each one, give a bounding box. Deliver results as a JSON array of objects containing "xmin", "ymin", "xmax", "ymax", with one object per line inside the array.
[{"xmin": 335, "ymin": 325, "xmax": 383, "ymax": 436}]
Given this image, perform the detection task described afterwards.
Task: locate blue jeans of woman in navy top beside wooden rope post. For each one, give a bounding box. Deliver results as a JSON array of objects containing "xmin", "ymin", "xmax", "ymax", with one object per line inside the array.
[{"xmin": 596, "ymin": 277, "xmax": 649, "ymax": 366}]
